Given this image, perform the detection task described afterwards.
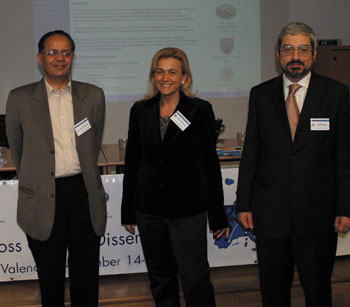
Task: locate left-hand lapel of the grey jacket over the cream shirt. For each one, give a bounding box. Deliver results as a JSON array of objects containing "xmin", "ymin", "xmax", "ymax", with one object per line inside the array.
[{"xmin": 32, "ymin": 78, "xmax": 54, "ymax": 148}]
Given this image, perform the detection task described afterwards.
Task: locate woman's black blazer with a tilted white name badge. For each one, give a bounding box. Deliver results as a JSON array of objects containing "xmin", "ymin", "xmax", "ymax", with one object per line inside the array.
[{"xmin": 122, "ymin": 94, "xmax": 227, "ymax": 230}]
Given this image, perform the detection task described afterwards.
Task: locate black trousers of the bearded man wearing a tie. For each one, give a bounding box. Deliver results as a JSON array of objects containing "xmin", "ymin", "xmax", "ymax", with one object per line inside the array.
[{"xmin": 255, "ymin": 229, "xmax": 337, "ymax": 307}]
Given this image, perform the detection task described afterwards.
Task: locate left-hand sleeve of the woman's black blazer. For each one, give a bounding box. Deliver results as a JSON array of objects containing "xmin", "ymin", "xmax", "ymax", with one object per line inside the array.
[{"xmin": 121, "ymin": 104, "xmax": 141, "ymax": 225}]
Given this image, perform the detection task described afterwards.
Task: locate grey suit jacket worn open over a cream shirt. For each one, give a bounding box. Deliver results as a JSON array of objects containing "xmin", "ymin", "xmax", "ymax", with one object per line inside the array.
[{"xmin": 6, "ymin": 79, "xmax": 107, "ymax": 240}]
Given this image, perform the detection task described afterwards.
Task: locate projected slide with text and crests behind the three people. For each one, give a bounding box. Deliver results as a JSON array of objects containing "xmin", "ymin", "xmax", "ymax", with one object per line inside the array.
[{"xmin": 33, "ymin": 0, "xmax": 261, "ymax": 101}]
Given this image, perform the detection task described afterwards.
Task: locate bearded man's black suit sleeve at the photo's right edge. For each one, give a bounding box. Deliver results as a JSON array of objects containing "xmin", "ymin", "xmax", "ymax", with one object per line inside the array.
[{"xmin": 335, "ymin": 86, "xmax": 350, "ymax": 217}]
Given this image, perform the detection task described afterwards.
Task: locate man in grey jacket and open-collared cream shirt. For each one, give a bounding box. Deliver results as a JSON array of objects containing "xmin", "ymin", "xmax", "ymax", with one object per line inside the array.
[{"xmin": 6, "ymin": 30, "xmax": 106, "ymax": 307}]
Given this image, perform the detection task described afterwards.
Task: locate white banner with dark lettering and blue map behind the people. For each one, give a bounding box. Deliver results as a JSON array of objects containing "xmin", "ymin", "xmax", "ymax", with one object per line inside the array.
[{"xmin": 0, "ymin": 168, "xmax": 350, "ymax": 281}]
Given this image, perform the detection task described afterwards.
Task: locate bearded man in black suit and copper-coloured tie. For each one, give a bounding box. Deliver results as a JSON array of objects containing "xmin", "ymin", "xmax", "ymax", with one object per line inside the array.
[{"xmin": 237, "ymin": 23, "xmax": 350, "ymax": 307}]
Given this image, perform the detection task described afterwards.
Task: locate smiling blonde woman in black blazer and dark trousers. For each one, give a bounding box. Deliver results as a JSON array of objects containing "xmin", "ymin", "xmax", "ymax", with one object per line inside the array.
[{"xmin": 122, "ymin": 48, "xmax": 228, "ymax": 307}]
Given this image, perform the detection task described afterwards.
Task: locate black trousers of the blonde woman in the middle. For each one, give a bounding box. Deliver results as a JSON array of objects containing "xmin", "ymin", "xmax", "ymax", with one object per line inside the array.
[{"xmin": 136, "ymin": 212, "xmax": 215, "ymax": 307}]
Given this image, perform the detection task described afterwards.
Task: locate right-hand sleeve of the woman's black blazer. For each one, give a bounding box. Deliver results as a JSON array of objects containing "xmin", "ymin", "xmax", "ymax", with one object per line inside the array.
[{"xmin": 201, "ymin": 103, "xmax": 228, "ymax": 231}]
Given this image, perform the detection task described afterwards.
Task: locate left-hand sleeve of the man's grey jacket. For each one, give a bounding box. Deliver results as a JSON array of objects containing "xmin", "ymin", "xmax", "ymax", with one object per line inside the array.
[{"xmin": 6, "ymin": 91, "xmax": 23, "ymax": 175}]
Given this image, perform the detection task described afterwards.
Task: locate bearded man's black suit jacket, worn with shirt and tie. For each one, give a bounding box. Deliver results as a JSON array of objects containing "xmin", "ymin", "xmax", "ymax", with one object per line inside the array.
[{"xmin": 237, "ymin": 73, "xmax": 350, "ymax": 238}]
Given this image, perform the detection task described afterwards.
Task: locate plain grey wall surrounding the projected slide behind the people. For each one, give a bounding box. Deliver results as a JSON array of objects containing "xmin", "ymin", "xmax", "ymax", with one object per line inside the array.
[{"xmin": 0, "ymin": 0, "xmax": 350, "ymax": 143}]
